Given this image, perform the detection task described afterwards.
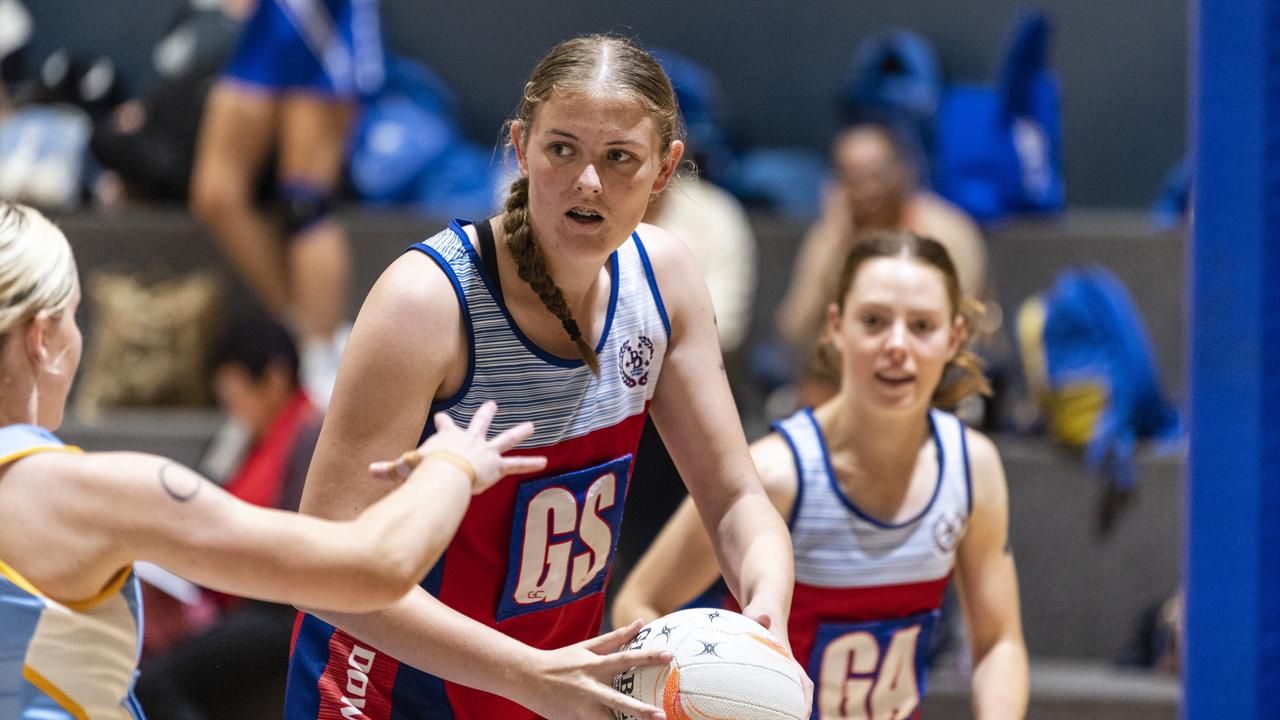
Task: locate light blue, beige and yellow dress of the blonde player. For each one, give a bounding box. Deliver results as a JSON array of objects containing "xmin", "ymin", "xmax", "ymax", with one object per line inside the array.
[{"xmin": 0, "ymin": 425, "xmax": 143, "ymax": 720}]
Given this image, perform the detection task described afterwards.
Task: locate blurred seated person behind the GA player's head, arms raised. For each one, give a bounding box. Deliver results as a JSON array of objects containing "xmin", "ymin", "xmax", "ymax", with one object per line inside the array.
[{"xmin": 777, "ymin": 123, "xmax": 992, "ymax": 405}]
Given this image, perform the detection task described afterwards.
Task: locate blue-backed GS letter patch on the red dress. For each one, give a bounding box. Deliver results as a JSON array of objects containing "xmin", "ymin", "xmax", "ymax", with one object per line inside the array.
[{"xmin": 495, "ymin": 454, "xmax": 631, "ymax": 621}]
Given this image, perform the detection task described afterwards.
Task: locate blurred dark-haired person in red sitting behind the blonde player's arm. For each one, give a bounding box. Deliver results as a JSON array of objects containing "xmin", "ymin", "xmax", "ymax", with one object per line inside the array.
[{"xmin": 137, "ymin": 318, "xmax": 321, "ymax": 720}]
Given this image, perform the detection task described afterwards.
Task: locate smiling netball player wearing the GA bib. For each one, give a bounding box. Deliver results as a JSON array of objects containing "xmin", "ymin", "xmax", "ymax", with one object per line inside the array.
[{"xmin": 614, "ymin": 232, "xmax": 1028, "ymax": 720}]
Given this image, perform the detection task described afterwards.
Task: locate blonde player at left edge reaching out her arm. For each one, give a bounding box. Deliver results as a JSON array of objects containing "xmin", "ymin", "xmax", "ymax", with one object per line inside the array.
[{"xmin": 0, "ymin": 202, "xmax": 544, "ymax": 720}]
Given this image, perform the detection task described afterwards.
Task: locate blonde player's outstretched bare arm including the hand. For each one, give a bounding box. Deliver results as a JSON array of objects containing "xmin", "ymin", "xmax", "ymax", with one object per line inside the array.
[{"xmin": 6, "ymin": 397, "xmax": 543, "ymax": 610}]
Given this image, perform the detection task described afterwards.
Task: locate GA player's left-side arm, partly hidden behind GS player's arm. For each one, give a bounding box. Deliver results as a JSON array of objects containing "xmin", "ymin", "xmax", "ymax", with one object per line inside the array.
[{"xmin": 612, "ymin": 434, "xmax": 796, "ymax": 626}]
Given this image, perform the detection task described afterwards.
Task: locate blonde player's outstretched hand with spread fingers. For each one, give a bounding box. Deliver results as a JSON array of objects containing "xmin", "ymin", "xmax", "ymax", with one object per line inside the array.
[{"xmin": 369, "ymin": 401, "xmax": 547, "ymax": 495}]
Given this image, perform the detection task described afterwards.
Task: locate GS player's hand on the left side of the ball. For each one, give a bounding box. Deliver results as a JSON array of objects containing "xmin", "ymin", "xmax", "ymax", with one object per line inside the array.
[{"xmin": 513, "ymin": 620, "xmax": 675, "ymax": 720}]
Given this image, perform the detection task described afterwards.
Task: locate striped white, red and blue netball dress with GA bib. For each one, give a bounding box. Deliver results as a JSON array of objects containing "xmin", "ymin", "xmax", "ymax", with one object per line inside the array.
[{"xmin": 774, "ymin": 410, "xmax": 973, "ymax": 720}]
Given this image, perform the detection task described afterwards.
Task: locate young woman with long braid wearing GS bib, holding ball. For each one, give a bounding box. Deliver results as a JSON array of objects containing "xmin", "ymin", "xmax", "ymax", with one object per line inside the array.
[{"xmin": 287, "ymin": 36, "xmax": 792, "ymax": 720}]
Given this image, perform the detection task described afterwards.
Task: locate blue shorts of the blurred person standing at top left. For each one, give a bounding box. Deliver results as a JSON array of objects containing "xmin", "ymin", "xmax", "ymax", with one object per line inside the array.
[{"xmin": 224, "ymin": 0, "xmax": 384, "ymax": 97}]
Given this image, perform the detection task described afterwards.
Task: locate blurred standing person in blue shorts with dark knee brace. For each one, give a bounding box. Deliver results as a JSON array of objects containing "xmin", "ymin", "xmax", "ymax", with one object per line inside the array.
[{"xmin": 191, "ymin": 0, "xmax": 384, "ymax": 405}]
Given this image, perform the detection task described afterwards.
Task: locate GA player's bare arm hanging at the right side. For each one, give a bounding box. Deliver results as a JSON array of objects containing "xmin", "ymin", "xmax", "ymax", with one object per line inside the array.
[{"xmin": 956, "ymin": 430, "xmax": 1029, "ymax": 720}]
